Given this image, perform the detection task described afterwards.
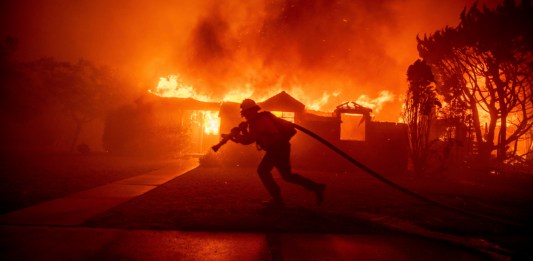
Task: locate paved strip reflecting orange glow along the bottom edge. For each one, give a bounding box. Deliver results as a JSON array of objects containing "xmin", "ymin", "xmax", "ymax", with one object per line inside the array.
[{"xmin": 0, "ymin": 226, "xmax": 492, "ymax": 261}]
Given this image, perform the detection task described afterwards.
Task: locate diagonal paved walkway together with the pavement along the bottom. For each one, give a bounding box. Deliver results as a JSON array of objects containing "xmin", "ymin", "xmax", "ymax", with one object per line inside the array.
[{"xmin": 0, "ymin": 157, "xmax": 506, "ymax": 260}]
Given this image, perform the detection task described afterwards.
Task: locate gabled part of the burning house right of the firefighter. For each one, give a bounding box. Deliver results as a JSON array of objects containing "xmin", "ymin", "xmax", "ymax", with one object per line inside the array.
[{"xmin": 250, "ymin": 92, "xmax": 408, "ymax": 174}]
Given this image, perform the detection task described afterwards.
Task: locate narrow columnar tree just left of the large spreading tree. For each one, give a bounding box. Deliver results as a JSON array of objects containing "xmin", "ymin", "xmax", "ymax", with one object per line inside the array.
[{"xmin": 402, "ymin": 60, "xmax": 440, "ymax": 173}]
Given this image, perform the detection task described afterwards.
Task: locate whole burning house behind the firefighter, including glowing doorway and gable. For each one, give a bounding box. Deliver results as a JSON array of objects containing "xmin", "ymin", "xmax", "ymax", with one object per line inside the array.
[{"xmin": 122, "ymin": 91, "xmax": 407, "ymax": 173}]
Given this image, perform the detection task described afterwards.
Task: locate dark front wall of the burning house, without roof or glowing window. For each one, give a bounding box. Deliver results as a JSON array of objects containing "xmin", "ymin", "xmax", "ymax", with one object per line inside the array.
[{"xmin": 214, "ymin": 97, "xmax": 408, "ymax": 175}]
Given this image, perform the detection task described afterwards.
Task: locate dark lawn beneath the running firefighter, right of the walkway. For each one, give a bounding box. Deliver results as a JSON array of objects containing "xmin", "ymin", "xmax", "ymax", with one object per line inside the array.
[{"xmin": 85, "ymin": 167, "xmax": 533, "ymax": 256}]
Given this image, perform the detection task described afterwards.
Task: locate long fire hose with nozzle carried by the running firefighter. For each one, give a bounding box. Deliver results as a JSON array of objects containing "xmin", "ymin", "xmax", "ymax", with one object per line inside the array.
[{"xmin": 212, "ymin": 123, "xmax": 533, "ymax": 229}]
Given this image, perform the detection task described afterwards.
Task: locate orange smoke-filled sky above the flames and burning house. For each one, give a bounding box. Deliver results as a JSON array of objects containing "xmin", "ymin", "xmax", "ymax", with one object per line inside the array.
[{"xmin": 0, "ymin": 0, "xmax": 499, "ymax": 120}]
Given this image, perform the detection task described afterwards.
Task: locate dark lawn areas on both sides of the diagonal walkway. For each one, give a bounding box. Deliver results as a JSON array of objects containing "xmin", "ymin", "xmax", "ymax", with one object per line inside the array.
[{"xmin": 0, "ymin": 149, "xmax": 533, "ymax": 253}]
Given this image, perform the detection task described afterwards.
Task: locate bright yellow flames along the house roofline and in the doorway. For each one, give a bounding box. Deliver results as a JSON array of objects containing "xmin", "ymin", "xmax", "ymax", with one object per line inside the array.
[{"xmin": 149, "ymin": 75, "xmax": 395, "ymax": 135}]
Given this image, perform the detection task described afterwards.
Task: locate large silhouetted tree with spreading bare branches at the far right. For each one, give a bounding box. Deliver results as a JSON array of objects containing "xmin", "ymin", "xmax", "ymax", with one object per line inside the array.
[{"xmin": 417, "ymin": 0, "xmax": 533, "ymax": 166}]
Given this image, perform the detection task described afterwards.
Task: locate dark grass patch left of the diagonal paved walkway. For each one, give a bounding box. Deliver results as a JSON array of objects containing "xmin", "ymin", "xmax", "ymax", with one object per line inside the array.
[{"xmin": 0, "ymin": 148, "xmax": 179, "ymax": 214}]
